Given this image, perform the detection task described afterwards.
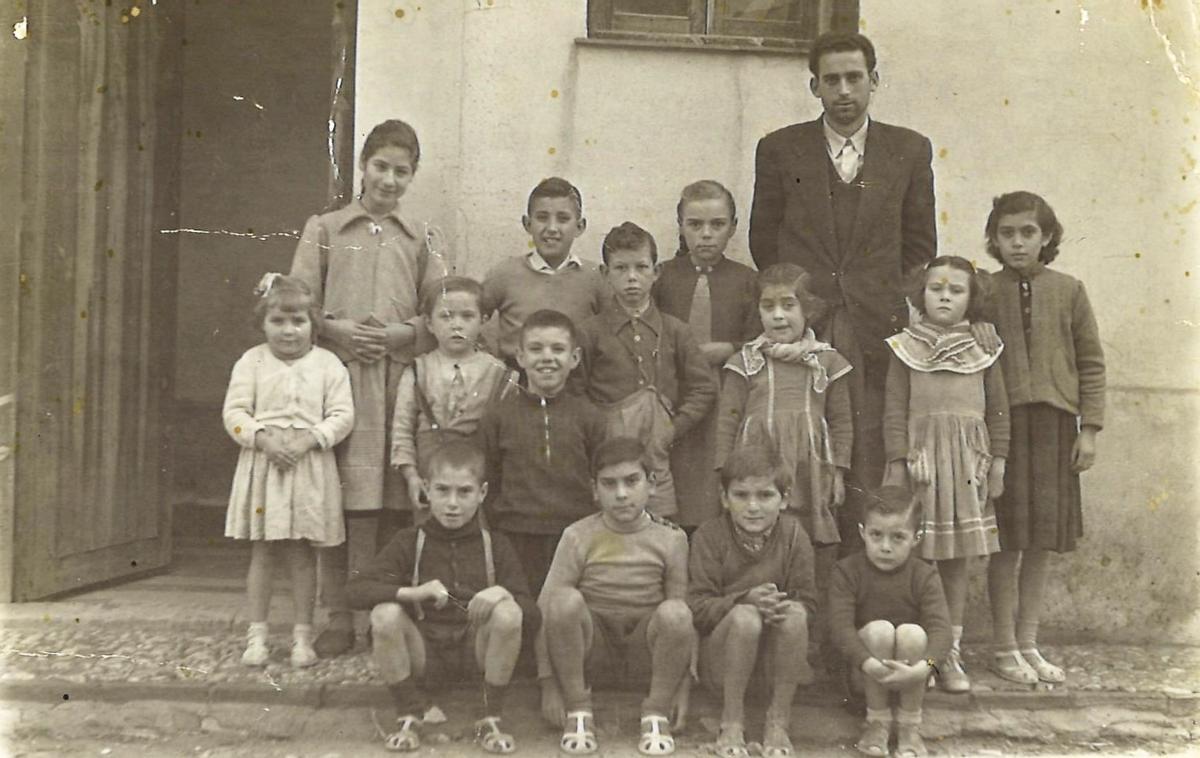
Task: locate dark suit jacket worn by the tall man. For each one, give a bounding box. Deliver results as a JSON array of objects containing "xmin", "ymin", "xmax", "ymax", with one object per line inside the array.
[{"xmin": 750, "ymin": 119, "xmax": 937, "ymax": 361}]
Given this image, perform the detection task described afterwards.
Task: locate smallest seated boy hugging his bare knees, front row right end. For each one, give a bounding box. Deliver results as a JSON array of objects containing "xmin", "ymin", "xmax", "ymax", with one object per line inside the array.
[{"xmin": 829, "ymin": 487, "xmax": 950, "ymax": 756}]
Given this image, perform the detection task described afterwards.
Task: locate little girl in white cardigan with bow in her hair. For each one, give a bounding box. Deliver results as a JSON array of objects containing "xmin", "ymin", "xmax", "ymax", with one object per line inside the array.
[{"xmin": 223, "ymin": 273, "xmax": 354, "ymax": 667}]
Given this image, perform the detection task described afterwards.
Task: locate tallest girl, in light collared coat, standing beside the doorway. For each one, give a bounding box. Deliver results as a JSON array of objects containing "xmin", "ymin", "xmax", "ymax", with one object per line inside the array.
[{"xmin": 292, "ymin": 120, "xmax": 450, "ymax": 656}]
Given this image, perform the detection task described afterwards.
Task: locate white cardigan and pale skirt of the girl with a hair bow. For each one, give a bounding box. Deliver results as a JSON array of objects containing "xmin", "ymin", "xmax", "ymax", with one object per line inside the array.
[{"xmin": 223, "ymin": 344, "xmax": 354, "ymax": 547}]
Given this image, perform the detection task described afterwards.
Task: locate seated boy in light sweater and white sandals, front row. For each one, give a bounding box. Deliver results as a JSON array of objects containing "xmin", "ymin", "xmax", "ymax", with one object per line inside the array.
[{"xmin": 538, "ymin": 437, "xmax": 696, "ymax": 756}]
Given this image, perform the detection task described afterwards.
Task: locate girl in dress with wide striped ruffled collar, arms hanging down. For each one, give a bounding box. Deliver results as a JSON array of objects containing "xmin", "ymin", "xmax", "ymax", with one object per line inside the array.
[{"xmin": 883, "ymin": 255, "xmax": 1009, "ymax": 692}]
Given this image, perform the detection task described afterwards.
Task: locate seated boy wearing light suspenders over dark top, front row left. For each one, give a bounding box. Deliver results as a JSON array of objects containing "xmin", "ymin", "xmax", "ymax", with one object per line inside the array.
[{"xmin": 346, "ymin": 440, "xmax": 539, "ymax": 753}]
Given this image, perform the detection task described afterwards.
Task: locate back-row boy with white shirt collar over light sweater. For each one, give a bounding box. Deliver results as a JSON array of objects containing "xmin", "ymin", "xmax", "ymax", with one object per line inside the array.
[{"xmin": 482, "ymin": 176, "xmax": 610, "ymax": 367}]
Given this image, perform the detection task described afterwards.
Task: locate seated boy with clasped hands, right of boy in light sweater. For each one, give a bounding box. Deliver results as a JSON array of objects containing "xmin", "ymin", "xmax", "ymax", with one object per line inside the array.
[{"xmin": 688, "ymin": 445, "xmax": 816, "ymax": 758}]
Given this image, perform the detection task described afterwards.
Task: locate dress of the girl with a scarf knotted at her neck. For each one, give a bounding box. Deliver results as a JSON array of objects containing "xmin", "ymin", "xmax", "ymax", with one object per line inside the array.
[{"xmin": 716, "ymin": 330, "xmax": 853, "ymax": 545}]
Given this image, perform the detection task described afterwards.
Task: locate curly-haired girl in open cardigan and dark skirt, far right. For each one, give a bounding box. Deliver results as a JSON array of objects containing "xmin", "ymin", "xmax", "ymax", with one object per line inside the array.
[{"xmin": 985, "ymin": 192, "xmax": 1104, "ymax": 684}]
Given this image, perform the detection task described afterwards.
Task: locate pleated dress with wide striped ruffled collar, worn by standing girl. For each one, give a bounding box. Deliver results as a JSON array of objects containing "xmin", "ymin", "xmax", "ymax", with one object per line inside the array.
[{"xmin": 884, "ymin": 323, "xmax": 1009, "ymax": 560}]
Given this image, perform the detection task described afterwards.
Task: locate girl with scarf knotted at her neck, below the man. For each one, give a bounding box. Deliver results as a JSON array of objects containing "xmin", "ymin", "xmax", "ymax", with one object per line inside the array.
[{"xmin": 716, "ymin": 263, "xmax": 854, "ymax": 666}]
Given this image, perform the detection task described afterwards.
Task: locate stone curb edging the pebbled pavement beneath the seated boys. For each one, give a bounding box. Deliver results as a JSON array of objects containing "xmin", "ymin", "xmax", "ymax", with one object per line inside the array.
[{"xmin": 0, "ymin": 679, "xmax": 1200, "ymax": 717}]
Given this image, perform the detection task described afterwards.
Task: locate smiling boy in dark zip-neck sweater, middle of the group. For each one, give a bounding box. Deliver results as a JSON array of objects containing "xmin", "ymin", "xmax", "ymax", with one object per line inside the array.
[{"xmin": 480, "ymin": 309, "xmax": 605, "ymax": 594}]
